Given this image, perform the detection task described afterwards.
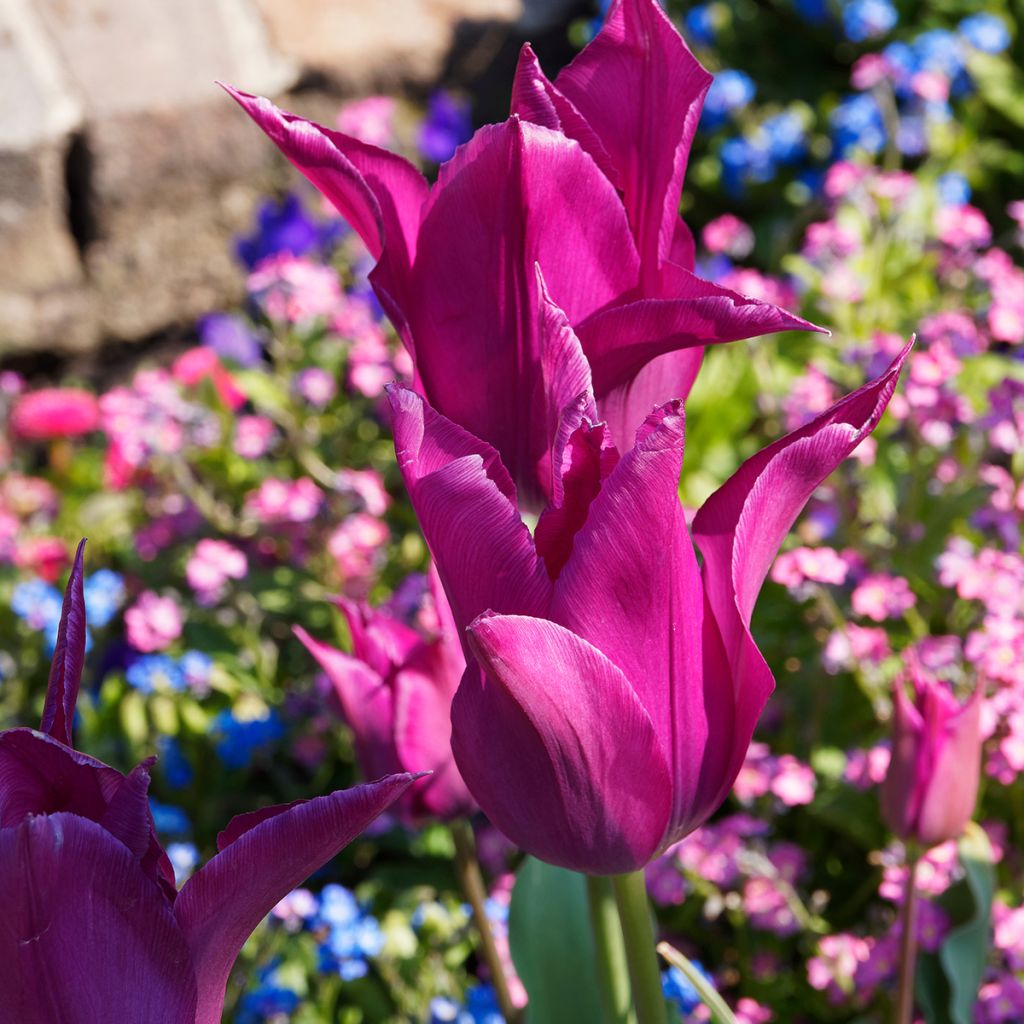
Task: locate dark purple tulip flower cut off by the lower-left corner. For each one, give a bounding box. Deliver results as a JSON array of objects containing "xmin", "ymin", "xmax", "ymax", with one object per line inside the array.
[{"xmin": 0, "ymin": 542, "xmax": 414, "ymax": 1024}]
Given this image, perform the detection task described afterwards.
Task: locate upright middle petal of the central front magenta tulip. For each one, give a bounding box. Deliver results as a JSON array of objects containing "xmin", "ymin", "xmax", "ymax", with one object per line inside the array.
[{"xmin": 550, "ymin": 402, "xmax": 712, "ymax": 821}]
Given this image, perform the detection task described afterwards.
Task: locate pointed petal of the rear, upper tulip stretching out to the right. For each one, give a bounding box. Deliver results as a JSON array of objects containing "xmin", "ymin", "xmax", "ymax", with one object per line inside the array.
[{"xmin": 577, "ymin": 267, "xmax": 822, "ymax": 399}]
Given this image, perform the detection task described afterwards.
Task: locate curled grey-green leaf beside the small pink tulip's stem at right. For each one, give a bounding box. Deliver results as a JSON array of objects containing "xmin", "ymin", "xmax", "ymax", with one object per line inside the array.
[{"xmin": 915, "ymin": 822, "xmax": 995, "ymax": 1024}]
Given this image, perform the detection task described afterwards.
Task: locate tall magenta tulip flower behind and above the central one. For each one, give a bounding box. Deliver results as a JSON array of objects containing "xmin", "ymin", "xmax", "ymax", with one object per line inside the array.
[{"xmin": 220, "ymin": 0, "xmax": 815, "ymax": 508}]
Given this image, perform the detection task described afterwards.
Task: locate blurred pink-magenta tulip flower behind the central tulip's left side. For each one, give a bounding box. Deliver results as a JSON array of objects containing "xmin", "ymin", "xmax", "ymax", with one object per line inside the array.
[{"xmin": 295, "ymin": 568, "xmax": 476, "ymax": 824}]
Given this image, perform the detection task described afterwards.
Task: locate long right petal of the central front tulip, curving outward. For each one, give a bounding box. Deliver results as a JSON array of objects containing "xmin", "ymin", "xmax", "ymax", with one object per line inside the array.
[{"xmin": 693, "ymin": 345, "xmax": 910, "ymax": 799}]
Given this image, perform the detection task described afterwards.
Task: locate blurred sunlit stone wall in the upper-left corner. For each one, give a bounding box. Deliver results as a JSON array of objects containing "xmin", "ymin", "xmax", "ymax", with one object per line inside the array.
[{"xmin": 0, "ymin": 0, "xmax": 566, "ymax": 358}]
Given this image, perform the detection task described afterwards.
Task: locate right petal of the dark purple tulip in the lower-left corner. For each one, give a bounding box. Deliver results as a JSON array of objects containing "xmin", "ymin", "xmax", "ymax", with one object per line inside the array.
[{"xmin": 174, "ymin": 775, "xmax": 415, "ymax": 1024}]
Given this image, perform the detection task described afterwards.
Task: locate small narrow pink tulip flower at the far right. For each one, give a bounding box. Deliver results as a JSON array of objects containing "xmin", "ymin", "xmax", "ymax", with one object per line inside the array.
[{"xmin": 882, "ymin": 664, "xmax": 984, "ymax": 848}]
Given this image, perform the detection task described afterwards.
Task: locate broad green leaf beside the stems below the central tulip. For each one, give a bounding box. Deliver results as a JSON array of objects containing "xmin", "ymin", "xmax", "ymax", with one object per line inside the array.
[{"xmin": 509, "ymin": 857, "xmax": 602, "ymax": 1024}]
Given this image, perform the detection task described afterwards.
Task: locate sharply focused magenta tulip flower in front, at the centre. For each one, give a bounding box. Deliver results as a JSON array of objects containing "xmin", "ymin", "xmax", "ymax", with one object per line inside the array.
[{"xmin": 389, "ymin": 327, "xmax": 906, "ymax": 874}]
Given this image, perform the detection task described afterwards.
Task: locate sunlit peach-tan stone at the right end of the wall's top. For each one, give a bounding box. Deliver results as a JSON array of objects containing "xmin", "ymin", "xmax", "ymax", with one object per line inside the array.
[{"xmin": 256, "ymin": 0, "xmax": 522, "ymax": 92}]
